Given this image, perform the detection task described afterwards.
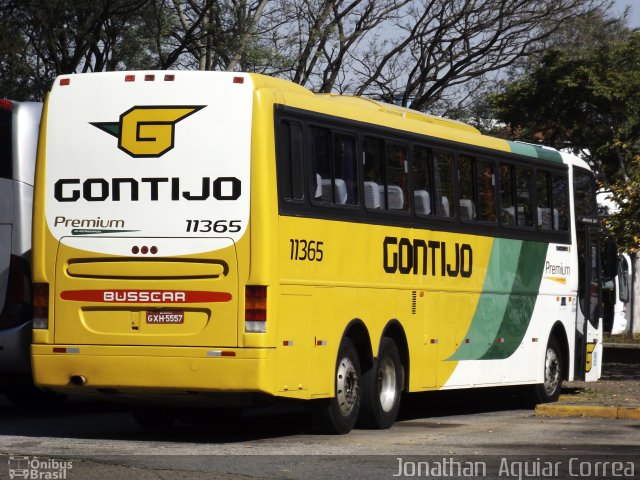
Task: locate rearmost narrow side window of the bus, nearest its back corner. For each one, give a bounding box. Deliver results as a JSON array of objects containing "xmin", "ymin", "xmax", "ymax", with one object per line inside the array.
[{"xmin": 277, "ymin": 120, "xmax": 304, "ymax": 201}]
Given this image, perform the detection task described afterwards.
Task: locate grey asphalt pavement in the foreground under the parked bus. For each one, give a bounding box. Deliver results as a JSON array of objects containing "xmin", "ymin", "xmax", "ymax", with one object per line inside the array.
[{"xmin": 0, "ymin": 390, "xmax": 640, "ymax": 480}]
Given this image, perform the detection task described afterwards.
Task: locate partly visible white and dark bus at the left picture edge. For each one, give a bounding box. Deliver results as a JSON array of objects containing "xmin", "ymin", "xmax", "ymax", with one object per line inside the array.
[{"xmin": 0, "ymin": 100, "xmax": 42, "ymax": 402}]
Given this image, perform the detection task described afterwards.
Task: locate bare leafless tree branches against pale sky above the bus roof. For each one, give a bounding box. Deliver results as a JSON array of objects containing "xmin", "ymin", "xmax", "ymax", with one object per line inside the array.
[{"xmin": 354, "ymin": 0, "xmax": 610, "ymax": 110}]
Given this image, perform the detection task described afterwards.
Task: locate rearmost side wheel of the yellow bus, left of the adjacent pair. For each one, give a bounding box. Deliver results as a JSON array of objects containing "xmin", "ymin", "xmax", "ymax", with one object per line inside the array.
[{"xmin": 313, "ymin": 337, "xmax": 362, "ymax": 435}]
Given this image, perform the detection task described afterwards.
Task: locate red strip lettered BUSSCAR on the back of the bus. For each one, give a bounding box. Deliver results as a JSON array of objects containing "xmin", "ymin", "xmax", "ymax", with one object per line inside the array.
[{"xmin": 60, "ymin": 290, "xmax": 232, "ymax": 303}]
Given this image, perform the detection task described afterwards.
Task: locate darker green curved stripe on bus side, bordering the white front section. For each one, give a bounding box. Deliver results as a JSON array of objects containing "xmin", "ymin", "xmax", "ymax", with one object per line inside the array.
[{"xmin": 480, "ymin": 242, "xmax": 549, "ymax": 360}]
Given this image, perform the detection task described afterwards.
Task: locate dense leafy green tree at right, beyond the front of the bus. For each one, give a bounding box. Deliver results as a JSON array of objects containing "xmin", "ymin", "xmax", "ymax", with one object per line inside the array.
[{"xmin": 487, "ymin": 11, "xmax": 640, "ymax": 252}]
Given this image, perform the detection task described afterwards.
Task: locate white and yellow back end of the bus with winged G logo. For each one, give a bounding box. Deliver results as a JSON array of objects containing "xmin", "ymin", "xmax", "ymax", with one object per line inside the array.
[{"xmin": 32, "ymin": 72, "xmax": 275, "ymax": 399}]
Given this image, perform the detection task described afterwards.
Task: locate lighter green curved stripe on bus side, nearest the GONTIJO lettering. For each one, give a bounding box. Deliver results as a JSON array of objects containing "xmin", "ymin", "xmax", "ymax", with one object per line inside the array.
[{"xmin": 448, "ymin": 238, "xmax": 523, "ymax": 360}]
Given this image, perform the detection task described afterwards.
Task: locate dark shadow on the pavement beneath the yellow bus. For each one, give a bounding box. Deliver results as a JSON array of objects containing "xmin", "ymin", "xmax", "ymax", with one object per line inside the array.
[{"xmin": 0, "ymin": 388, "xmax": 536, "ymax": 444}]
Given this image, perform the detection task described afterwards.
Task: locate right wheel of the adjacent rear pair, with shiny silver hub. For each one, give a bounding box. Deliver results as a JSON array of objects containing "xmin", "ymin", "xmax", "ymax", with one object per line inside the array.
[{"xmin": 358, "ymin": 337, "xmax": 403, "ymax": 429}]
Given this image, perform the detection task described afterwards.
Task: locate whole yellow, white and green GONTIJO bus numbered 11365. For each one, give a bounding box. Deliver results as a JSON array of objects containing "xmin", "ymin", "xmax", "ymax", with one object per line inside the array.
[{"xmin": 32, "ymin": 71, "xmax": 602, "ymax": 433}]
